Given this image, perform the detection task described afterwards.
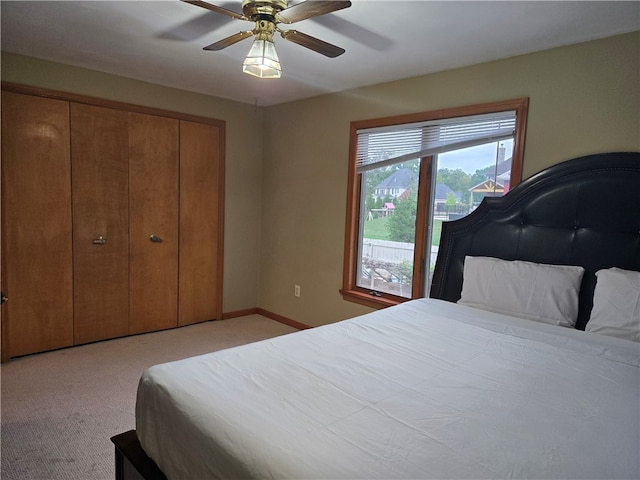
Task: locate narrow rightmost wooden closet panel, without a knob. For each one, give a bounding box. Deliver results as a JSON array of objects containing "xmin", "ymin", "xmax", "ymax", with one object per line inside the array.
[{"xmin": 178, "ymin": 121, "xmax": 222, "ymax": 325}]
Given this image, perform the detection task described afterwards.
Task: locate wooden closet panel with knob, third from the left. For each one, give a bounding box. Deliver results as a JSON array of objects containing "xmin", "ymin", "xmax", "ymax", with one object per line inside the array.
[{"xmin": 129, "ymin": 113, "xmax": 179, "ymax": 333}]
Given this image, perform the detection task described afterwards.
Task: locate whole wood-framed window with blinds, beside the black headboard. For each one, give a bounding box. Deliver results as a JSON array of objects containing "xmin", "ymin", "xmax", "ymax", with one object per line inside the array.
[{"xmin": 341, "ymin": 98, "xmax": 528, "ymax": 307}]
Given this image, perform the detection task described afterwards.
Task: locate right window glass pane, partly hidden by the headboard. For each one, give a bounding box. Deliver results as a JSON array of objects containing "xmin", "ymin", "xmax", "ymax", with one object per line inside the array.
[{"xmin": 428, "ymin": 138, "xmax": 513, "ymax": 272}]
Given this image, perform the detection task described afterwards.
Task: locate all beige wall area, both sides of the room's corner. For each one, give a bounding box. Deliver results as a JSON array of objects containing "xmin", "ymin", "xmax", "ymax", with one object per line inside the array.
[{"xmin": 2, "ymin": 33, "xmax": 640, "ymax": 326}]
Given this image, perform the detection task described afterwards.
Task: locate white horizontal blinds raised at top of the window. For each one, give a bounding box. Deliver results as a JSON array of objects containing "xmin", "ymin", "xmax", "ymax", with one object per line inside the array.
[{"xmin": 356, "ymin": 111, "xmax": 516, "ymax": 173}]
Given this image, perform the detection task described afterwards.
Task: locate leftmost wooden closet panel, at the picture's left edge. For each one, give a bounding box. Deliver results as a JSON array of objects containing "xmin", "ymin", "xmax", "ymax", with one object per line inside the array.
[{"xmin": 2, "ymin": 91, "xmax": 73, "ymax": 358}]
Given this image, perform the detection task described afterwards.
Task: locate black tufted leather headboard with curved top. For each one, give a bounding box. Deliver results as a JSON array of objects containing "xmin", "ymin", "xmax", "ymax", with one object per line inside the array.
[{"xmin": 430, "ymin": 152, "xmax": 640, "ymax": 330}]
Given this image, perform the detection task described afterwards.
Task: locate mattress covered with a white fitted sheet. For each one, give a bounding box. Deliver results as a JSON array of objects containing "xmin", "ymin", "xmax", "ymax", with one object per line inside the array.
[{"xmin": 136, "ymin": 299, "xmax": 640, "ymax": 479}]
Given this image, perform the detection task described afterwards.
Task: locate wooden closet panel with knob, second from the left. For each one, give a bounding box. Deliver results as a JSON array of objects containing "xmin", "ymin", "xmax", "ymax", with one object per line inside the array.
[{"xmin": 71, "ymin": 103, "xmax": 129, "ymax": 344}]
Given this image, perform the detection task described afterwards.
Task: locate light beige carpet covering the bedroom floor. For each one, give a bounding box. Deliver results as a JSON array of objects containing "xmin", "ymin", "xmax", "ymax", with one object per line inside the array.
[{"xmin": 0, "ymin": 315, "xmax": 295, "ymax": 480}]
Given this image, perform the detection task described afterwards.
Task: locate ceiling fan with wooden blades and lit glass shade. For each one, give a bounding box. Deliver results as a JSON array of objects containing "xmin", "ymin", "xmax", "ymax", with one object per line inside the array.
[{"xmin": 182, "ymin": 0, "xmax": 351, "ymax": 78}]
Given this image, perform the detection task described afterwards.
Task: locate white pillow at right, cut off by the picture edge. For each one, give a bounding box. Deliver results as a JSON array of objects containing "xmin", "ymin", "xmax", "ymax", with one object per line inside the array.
[{"xmin": 585, "ymin": 268, "xmax": 640, "ymax": 342}]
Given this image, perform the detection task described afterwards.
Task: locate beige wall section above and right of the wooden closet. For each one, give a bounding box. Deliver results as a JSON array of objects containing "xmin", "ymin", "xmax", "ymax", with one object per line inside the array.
[{"xmin": 2, "ymin": 52, "xmax": 263, "ymax": 312}]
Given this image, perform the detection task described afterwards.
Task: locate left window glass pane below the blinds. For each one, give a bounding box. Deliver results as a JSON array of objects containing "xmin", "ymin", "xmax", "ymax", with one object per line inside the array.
[{"xmin": 356, "ymin": 160, "xmax": 420, "ymax": 298}]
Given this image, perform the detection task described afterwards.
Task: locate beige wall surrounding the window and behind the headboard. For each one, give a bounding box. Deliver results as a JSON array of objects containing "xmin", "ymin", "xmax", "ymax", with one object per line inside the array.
[{"xmin": 259, "ymin": 33, "xmax": 640, "ymax": 326}]
